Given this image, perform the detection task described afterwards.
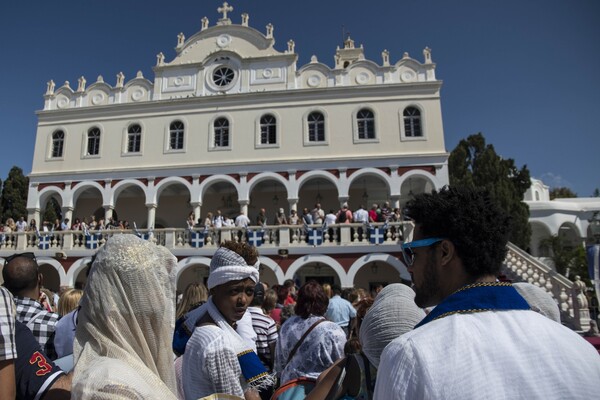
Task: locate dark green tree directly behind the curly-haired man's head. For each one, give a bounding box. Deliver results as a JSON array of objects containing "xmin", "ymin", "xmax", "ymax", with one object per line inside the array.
[{"xmin": 448, "ymin": 133, "xmax": 531, "ymax": 249}]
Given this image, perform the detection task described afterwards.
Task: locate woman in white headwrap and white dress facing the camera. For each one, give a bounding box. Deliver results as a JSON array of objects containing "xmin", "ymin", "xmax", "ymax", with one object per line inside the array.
[{"xmin": 182, "ymin": 242, "xmax": 273, "ymax": 400}]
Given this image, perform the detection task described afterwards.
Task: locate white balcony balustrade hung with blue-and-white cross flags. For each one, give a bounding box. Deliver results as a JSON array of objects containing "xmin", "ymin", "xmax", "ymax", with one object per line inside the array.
[{"xmin": 0, "ymin": 222, "xmax": 413, "ymax": 257}]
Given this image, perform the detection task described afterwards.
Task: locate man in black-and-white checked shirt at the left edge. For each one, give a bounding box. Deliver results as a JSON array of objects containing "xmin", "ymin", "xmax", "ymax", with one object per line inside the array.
[{"xmin": 2, "ymin": 253, "xmax": 60, "ymax": 359}]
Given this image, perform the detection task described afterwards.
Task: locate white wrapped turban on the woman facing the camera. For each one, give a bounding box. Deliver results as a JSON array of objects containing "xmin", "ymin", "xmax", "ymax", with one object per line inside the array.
[{"xmin": 207, "ymin": 247, "xmax": 260, "ymax": 289}]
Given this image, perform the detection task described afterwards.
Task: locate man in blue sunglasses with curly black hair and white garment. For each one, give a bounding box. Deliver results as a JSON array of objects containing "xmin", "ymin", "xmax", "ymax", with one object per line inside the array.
[{"xmin": 375, "ymin": 188, "xmax": 600, "ymax": 400}]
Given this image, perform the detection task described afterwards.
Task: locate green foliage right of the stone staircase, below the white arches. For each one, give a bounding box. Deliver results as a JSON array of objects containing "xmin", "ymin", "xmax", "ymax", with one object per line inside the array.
[{"xmin": 540, "ymin": 235, "xmax": 591, "ymax": 285}]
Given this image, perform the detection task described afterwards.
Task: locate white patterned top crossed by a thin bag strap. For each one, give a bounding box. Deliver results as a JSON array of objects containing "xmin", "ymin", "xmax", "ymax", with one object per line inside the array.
[{"xmin": 275, "ymin": 315, "xmax": 346, "ymax": 383}]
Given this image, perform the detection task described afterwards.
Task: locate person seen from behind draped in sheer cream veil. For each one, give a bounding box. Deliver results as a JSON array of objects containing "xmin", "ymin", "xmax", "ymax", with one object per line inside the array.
[{"xmin": 72, "ymin": 235, "xmax": 177, "ymax": 399}]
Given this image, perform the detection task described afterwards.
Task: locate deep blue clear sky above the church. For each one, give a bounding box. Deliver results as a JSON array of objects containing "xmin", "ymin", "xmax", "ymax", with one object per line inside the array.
[{"xmin": 0, "ymin": 0, "xmax": 600, "ymax": 196}]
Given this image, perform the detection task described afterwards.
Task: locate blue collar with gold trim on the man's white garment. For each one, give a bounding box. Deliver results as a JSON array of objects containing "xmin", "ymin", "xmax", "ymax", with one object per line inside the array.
[{"xmin": 415, "ymin": 282, "xmax": 530, "ymax": 329}]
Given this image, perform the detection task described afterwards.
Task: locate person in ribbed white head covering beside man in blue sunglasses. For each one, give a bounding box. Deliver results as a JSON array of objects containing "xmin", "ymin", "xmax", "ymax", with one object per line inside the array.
[{"xmin": 306, "ymin": 283, "xmax": 425, "ymax": 400}]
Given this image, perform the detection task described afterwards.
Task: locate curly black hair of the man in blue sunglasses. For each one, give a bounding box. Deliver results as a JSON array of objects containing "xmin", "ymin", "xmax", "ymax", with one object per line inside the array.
[{"xmin": 406, "ymin": 187, "xmax": 510, "ymax": 278}]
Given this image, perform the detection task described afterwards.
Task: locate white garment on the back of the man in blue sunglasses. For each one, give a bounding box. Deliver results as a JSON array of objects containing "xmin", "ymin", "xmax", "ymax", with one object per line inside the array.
[{"xmin": 375, "ymin": 310, "xmax": 600, "ymax": 400}]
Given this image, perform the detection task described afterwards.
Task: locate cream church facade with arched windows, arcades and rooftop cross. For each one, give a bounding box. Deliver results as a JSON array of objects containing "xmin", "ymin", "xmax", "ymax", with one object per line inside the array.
[{"xmin": 14, "ymin": 3, "xmax": 448, "ymax": 290}]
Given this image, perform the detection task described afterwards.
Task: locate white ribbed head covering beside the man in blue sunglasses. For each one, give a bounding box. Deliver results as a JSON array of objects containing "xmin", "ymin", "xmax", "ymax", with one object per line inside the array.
[{"xmin": 358, "ymin": 283, "xmax": 425, "ymax": 368}]
